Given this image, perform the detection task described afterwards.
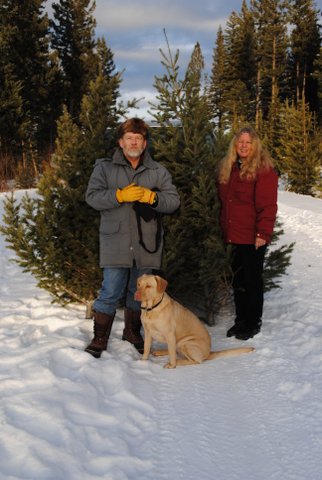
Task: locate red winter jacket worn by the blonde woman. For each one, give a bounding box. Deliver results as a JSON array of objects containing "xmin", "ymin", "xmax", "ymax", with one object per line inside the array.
[{"xmin": 218, "ymin": 163, "xmax": 278, "ymax": 244}]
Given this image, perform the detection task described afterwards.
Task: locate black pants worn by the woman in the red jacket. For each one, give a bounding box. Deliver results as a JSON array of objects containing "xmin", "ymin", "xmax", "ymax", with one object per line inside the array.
[{"xmin": 232, "ymin": 245, "xmax": 266, "ymax": 328}]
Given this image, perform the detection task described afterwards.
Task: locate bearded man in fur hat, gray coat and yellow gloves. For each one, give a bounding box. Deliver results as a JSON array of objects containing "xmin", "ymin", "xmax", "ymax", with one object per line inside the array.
[{"xmin": 85, "ymin": 118, "xmax": 180, "ymax": 358}]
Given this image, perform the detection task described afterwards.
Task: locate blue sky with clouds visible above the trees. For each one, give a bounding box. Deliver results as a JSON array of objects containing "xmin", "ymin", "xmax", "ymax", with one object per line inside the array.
[{"xmin": 47, "ymin": 0, "xmax": 322, "ymax": 118}]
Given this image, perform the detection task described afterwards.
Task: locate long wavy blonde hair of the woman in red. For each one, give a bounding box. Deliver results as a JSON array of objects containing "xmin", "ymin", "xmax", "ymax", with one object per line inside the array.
[{"xmin": 217, "ymin": 127, "xmax": 273, "ymax": 183}]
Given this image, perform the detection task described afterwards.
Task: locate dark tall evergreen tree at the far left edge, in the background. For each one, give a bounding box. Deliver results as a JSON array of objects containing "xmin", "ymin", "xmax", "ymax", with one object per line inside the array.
[{"xmin": 0, "ymin": 0, "xmax": 51, "ymax": 170}]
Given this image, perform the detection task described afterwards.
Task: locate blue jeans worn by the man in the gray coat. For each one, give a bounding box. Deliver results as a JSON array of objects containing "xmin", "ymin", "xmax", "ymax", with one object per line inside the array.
[{"xmin": 93, "ymin": 266, "xmax": 152, "ymax": 315}]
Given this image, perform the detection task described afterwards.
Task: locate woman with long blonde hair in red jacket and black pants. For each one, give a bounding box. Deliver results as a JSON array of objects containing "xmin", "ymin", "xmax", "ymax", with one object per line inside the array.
[{"xmin": 217, "ymin": 127, "xmax": 278, "ymax": 340}]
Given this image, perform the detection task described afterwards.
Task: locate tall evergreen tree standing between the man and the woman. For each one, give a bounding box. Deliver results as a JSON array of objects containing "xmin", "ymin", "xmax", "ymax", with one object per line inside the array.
[{"xmin": 153, "ymin": 35, "xmax": 227, "ymax": 323}]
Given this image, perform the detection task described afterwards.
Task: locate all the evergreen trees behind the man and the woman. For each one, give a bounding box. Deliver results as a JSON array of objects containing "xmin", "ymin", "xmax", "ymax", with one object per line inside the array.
[{"xmin": 0, "ymin": 0, "xmax": 322, "ymax": 323}]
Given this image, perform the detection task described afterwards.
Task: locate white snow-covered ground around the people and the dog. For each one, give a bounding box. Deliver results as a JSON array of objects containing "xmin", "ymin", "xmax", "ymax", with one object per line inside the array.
[{"xmin": 0, "ymin": 192, "xmax": 322, "ymax": 480}]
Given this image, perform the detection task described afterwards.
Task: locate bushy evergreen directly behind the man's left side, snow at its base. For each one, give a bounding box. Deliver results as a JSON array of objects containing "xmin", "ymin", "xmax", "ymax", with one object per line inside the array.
[{"xmin": 2, "ymin": 42, "xmax": 124, "ymax": 316}]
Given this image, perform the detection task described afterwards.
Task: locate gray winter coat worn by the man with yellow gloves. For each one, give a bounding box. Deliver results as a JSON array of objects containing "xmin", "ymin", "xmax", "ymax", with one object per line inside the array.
[{"xmin": 86, "ymin": 148, "xmax": 180, "ymax": 269}]
